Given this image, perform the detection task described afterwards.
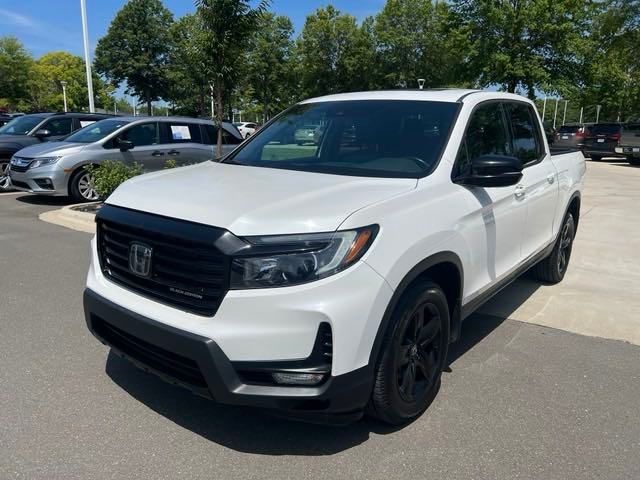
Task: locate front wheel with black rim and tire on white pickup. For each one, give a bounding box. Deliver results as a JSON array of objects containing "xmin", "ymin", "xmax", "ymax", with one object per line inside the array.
[{"xmin": 368, "ymin": 281, "xmax": 450, "ymax": 425}]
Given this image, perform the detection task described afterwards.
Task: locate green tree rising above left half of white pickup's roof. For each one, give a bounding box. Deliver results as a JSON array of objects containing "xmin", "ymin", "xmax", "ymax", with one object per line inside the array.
[{"xmin": 297, "ymin": 5, "xmax": 375, "ymax": 96}]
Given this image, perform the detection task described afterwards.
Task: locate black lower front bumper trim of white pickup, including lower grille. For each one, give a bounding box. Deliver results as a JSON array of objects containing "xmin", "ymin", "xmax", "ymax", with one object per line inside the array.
[{"xmin": 84, "ymin": 289, "xmax": 373, "ymax": 423}]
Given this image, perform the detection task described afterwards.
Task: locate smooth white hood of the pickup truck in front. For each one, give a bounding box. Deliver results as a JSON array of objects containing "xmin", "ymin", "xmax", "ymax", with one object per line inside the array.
[{"xmin": 107, "ymin": 162, "xmax": 417, "ymax": 236}]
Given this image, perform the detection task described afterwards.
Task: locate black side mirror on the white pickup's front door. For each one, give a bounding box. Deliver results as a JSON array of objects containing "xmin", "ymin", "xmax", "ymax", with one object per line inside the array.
[{"xmin": 456, "ymin": 155, "xmax": 522, "ymax": 187}]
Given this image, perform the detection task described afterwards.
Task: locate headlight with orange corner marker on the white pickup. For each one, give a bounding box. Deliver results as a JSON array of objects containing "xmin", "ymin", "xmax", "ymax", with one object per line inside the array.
[{"xmin": 230, "ymin": 225, "xmax": 378, "ymax": 290}]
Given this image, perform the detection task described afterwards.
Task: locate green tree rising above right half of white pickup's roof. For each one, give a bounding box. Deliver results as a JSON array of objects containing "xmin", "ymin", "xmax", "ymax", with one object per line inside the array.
[{"xmin": 374, "ymin": 0, "xmax": 470, "ymax": 88}]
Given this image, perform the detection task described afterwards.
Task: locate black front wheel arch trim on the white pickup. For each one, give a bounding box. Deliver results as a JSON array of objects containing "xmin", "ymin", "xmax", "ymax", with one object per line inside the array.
[{"xmin": 369, "ymin": 251, "xmax": 464, "ymax": 367}]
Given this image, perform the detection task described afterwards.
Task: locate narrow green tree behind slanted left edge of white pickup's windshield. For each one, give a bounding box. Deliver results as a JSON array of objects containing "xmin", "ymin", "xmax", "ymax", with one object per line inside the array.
[{"xmin": 245, "ymin": 13, "xmax": 296, "ymax": 120}]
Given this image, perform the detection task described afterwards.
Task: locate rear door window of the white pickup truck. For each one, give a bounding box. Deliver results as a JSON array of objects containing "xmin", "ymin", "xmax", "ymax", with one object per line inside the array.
[{"xmin": 507, "ymin": 103, "xmax": 542, "ymax": 166}]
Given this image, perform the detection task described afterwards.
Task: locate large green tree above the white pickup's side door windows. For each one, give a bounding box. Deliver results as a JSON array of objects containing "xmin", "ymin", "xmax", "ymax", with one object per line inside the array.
[{"xmin": 453, "ymin": 0, "xmax": 597, "ymax": 97}]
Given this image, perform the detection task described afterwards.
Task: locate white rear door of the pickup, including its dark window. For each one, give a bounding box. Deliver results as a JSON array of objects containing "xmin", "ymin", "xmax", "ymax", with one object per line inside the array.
[{"xmin": 505, "ymin": 102, "xmax": 558, "ymax": 261}]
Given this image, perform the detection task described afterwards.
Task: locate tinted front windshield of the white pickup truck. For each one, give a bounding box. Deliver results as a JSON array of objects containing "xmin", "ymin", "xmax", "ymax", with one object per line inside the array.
[{"xmin": 225, "ymin": 100, "xmax": 459, "ymax": 178}]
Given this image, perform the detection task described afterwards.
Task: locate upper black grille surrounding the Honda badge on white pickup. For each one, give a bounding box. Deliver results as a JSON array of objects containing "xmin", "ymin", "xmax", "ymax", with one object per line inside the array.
[{"xmin": 97, "ymin": 205, "xmax": 230, "ymax": 316}]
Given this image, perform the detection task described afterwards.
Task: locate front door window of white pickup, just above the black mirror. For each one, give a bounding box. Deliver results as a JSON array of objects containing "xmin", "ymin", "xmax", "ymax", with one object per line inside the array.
[{"xmin": 455, "ymin": 102, "xmax": 513, "ymax": 176}]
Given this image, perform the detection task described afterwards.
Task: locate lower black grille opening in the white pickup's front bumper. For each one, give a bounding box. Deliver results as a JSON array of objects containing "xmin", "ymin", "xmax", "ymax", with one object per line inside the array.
[{"xmin": 91, "ymin": 315, "xmax": 207, "ymax": 388}]
